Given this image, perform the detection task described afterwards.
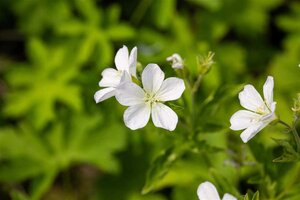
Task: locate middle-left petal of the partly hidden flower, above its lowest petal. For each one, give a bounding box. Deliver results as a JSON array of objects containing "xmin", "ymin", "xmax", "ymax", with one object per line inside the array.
[{"xmin": 99, "ymin": 68, "xmax": 121, "ymax": 87}]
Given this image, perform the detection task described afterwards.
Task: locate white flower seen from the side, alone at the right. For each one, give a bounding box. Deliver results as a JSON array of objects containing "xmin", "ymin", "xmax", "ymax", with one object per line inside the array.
[{"xmin": 230, "ymin": 76, "xmax": 277, "ymax": 143}]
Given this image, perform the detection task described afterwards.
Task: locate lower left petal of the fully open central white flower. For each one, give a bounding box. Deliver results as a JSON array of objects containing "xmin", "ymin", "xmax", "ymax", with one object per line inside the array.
[{"xmin": 124, "ymin": 103, "xmax": 151, "ymax": 130}]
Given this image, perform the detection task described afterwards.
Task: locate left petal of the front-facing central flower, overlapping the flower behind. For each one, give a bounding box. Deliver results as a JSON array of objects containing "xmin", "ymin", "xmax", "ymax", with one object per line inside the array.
[{"xmin": 116, "ymin": 82, "xmax": 145, "ymax": 106}]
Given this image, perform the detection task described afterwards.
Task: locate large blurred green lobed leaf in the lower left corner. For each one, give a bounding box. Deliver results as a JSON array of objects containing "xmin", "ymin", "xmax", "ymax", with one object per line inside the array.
[{"xmin": 0, "ymin": 113, "xmax": 126, "ymax": 199}]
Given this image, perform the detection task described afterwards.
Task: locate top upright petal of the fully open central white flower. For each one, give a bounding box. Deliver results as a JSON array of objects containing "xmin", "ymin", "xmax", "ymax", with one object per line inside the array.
[{"xmin": 142, "ymin": 64, "xmax": 165, "ymax": 94}]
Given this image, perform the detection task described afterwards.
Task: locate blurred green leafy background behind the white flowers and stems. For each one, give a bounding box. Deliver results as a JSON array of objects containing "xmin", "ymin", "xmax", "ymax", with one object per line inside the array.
[{"xmin": 0, "ymin": 0, "xmax": 300, "ymax": 200}]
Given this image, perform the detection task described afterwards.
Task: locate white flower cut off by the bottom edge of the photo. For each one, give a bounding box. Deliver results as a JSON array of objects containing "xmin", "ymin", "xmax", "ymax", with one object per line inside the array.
[{"xmin": 197, "ymin": 181, "xmax": 237, "ymax": 200}]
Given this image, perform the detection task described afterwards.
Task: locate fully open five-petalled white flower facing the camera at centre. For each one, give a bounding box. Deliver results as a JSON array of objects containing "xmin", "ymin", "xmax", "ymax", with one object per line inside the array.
[{"xmin": 116, "ymin": 64, "xmax": 185, "ymax": 131}]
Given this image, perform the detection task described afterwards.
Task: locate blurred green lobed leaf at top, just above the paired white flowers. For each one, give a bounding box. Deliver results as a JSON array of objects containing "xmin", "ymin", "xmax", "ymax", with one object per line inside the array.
[{"xmin": 53, "ymin": 0, "xmax": 135, "ymax": 66}]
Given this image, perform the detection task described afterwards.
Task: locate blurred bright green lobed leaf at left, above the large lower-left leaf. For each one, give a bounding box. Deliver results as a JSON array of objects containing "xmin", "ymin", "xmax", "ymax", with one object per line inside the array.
[{"xmin": 4, "ymin": 38, "xmax": 82, "ymax": 129}]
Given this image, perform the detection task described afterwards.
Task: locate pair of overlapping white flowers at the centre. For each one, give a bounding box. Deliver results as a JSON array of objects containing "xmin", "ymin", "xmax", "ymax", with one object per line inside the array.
[{"xmin": 94, "ymin": 46, "xmax": 185, "ymax": 131}]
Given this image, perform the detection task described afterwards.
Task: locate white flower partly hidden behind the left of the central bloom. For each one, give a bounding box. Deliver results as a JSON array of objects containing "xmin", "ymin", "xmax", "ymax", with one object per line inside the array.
[{"xmin": 94, "ymin": 45, "xmax": 137, "ymax": 103}]
